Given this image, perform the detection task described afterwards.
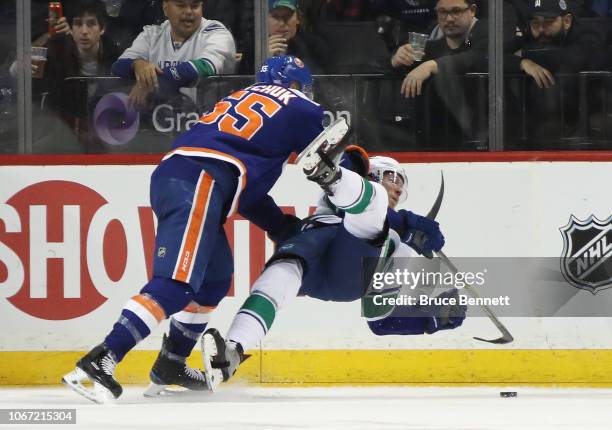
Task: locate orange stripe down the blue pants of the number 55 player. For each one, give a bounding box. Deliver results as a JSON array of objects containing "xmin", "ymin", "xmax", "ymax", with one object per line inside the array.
[{"xmin": 173, "ymin": 172, "xmax": 215, "ymax": 282}]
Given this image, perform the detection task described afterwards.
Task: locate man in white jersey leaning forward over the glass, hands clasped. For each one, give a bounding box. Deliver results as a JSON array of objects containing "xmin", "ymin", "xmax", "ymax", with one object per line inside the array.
[{"xmin": 112, "ymin": 0, "xmax": 236, "ymax": 107}]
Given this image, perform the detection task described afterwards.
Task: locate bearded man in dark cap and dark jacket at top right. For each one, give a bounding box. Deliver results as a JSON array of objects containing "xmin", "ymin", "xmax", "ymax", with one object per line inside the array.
[{"xmin": 505, "ymin": 0, "xmax": 605, "ymax": 148}]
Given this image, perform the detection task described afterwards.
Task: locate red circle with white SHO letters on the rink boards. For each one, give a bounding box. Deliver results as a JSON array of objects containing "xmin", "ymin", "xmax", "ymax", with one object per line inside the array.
[{"xmin": 0, "ymin": 181, "xmax": 153, "ymax": 320}]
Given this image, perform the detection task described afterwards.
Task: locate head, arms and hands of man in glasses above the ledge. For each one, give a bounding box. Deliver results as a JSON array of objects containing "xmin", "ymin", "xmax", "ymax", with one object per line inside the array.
[{"xmin": 391, "ymin": 0, "xmax": 488, "ymax": 97}]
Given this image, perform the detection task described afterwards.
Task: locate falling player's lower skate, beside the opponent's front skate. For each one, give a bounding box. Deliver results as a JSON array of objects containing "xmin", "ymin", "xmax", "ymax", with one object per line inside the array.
[{"xmin": 201, "ymin": 328, "xmax": 248, "ymax": 391}]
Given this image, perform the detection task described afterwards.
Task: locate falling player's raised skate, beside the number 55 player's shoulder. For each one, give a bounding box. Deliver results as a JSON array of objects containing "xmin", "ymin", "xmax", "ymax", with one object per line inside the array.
[{"xmin": 296, "ymin": 118, "xmax": 349, "ymax": 190}]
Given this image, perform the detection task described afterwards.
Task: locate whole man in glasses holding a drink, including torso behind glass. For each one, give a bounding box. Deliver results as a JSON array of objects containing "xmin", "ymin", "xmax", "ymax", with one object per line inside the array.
[{"xmin": 384, "ymin": 0, "xmax": 488, "ymax": 150}]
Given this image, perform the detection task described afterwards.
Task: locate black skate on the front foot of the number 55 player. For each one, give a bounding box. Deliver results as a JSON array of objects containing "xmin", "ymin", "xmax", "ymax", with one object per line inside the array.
[{"xmin": 144, "ymin": 334, "xmax": 209, "ymax": 397}]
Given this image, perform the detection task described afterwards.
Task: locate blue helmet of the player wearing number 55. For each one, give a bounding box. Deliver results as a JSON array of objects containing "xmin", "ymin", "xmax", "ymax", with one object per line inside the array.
[{"xmin": 257, "ymin": 55, "xmax": 313, "ymax": 100}]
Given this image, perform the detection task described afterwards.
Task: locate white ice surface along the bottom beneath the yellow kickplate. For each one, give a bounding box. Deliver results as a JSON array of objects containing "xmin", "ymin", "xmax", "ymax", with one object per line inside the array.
[{"xmin": 0, "ymin": 385, "xmax": 612, "ymax": 430}]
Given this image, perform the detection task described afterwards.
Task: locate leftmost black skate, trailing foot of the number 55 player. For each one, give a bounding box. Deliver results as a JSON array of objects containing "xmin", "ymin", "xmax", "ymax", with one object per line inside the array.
[{"xmin": 62, "ymin": 343, "xmax": 123, "ymax": 403}]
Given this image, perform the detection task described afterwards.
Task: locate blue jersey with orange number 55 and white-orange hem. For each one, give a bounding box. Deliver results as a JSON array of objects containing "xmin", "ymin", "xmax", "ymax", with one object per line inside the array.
[{"xmin": 165, "ymin": 84, "xmax": 323, "ymax": 212}]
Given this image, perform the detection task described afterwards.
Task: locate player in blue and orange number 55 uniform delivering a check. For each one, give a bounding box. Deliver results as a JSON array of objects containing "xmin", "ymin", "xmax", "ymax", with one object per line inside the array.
[{"xmin": 62, "ymin": 56, "xmax": 348, "ymax": 402}]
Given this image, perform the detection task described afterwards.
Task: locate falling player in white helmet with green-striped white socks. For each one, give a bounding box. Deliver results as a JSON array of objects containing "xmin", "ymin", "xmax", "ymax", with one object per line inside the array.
[{"xmin": 202, "ymin": 148, "xmax": 466, "ymax": 387}]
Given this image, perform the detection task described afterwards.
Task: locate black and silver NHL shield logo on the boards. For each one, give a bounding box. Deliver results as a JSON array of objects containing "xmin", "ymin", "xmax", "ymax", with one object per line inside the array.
[{"xmin": 560, "ymin": 215, "xmax": 612, "ymax": 294}]
